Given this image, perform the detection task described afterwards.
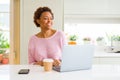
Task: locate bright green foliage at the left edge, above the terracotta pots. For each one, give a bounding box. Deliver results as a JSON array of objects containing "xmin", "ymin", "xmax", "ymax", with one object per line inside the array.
[{"xmin": 0, "ymin": 33, "xmax": 10, "ymax": 54}]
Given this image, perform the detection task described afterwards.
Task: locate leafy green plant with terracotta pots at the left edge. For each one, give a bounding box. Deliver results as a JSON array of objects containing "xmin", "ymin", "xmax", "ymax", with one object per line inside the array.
[{"xmin": 0, "ymin": 33, "xmax": 10, "ymax": 63}]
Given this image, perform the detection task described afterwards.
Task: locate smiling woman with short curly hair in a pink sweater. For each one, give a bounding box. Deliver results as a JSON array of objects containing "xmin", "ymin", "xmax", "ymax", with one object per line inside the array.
[{"xmin": 28, "ymin": 7, "xmax": 65, "ymax": 66}]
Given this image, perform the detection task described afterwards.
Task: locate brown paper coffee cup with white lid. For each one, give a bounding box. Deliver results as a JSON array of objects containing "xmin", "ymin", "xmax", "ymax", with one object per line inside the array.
[{"xmin": 43, "ymin": 59, "xmax": 53, "ymax": 71}]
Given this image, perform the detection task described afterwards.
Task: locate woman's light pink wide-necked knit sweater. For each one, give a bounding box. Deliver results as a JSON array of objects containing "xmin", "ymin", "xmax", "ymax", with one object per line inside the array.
[{"xmin": 28, "ymin": 31, "xmax": 66, "ymax": 64}]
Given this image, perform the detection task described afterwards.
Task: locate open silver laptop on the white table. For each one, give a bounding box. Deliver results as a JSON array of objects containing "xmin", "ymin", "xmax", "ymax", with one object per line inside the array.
[{"xmin": 53, "ymin": 44, "xmax": 94, "ymax": 72}]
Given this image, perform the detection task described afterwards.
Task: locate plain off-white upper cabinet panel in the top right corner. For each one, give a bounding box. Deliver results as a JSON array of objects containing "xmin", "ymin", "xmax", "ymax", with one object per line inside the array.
[{"xmin": 64, "ymin": 0, "xmax": 120, "ymax": 15}]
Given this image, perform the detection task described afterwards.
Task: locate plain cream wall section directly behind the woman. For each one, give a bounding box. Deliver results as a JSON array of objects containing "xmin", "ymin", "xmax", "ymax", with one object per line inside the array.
[{"xmin": 20, "ymin": 0, "xmax": 63, "ymax": 64}]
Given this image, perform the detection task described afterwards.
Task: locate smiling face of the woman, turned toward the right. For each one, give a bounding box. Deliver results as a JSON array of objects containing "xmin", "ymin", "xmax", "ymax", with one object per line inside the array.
[{"xmin": 37, "ymin": 12, "xmax": 53, "ymax": 29}]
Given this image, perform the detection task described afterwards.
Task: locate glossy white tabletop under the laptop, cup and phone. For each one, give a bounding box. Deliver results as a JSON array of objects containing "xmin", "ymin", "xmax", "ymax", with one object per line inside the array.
[{"xmin": 0, "ymin": 65, "xmax": 120, "ymax": 80}]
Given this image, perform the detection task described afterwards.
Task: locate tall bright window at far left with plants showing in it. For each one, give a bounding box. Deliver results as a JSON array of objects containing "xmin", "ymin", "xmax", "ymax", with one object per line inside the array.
[{"xmin": 0, "ymin": 0, "xmax": 10, "ymax": 64}]
